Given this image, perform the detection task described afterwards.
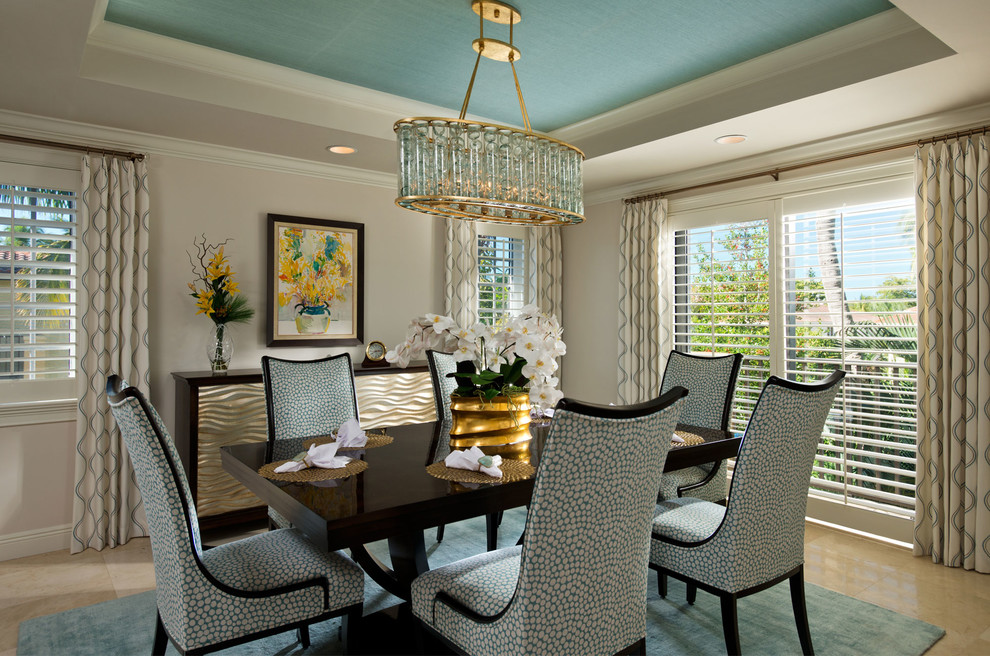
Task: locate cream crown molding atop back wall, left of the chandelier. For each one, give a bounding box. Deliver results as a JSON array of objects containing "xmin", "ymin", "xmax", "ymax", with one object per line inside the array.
[{"xmin": 0, "ymin": 110, "xmax": 396, "ymax": 190}]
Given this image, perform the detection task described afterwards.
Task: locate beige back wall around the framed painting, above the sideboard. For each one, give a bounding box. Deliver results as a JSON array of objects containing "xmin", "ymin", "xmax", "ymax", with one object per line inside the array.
[{"xmin": 150, "ymin": 156, "xmax": 443, "ymax": 428}]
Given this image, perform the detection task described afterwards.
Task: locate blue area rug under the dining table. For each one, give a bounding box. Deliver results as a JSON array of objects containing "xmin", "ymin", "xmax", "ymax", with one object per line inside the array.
[{"xmin": 17, "ymin": 509, "xmax": 945, "ymax": 656}]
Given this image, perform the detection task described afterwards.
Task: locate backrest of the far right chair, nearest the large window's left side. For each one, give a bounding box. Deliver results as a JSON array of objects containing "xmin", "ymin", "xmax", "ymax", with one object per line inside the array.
[{"xmin": 660, "ymin": 351, "xmax": 742, "ymax": 430}]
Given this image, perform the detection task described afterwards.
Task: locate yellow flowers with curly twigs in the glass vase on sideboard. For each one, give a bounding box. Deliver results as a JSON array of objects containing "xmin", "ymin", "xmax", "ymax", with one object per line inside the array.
[{"xmin": 187, "ymin": 235, "xmax": 254, "ymax": 326}]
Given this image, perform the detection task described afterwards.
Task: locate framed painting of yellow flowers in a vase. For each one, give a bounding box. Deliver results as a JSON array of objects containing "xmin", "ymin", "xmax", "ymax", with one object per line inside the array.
[{"xmin": 266, "ymin": 214, "xmax": 364, "ymax": 346}]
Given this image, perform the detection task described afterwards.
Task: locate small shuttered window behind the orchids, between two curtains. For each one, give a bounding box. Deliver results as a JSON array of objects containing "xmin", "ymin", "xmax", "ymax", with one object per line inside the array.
[{"xmin": 478, "ymin": 235, "xmax": 526, "ymax": 326}]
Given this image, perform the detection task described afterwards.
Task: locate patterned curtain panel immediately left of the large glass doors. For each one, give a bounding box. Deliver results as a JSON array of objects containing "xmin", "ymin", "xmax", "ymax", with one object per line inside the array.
[{"xmin": 619, "ymin": 198, "xmax": 674, "ymax": 404}]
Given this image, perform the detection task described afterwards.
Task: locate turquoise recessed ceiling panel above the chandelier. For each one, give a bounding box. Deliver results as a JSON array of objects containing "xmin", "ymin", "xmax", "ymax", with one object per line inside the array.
[{"xmin": 106, "ymin": 0, "xmax": 892, "ymax": 131}]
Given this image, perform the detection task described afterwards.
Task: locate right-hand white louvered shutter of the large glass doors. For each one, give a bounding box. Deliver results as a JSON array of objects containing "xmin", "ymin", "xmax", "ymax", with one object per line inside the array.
[{"xmin": 782, "ymin": 195, "xmax": 918, "ymax": 517}]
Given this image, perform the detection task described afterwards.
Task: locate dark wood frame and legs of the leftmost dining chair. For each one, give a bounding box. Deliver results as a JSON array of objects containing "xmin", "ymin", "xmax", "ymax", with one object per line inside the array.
[{"xmin": 106, "ymin": 374, "xmax": 363, "ymax": 656}]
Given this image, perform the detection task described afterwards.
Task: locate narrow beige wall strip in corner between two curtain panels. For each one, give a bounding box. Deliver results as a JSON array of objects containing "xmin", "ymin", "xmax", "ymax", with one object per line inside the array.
[{"xmin": 561, "ymin": 201, "xmax": 622, "ymax": 403}]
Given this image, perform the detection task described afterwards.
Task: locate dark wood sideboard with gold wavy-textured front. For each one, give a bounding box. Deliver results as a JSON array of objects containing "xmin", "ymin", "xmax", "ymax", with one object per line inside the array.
[{"xmin": 172, "ymin": 362, "xmax": 436, "ymax": 529}]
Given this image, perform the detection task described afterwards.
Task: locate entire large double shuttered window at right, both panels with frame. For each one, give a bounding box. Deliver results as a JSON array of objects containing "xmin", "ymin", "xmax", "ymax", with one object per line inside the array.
[{"xmin": 671, "ymin": 165, "xmax": 918, "ymax": 541}]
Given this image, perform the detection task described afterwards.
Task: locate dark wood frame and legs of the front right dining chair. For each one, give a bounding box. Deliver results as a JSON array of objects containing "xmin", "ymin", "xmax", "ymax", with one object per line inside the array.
[{"xmin": 650, "ymin": 370, "xmax": 845, "ymax": 656}]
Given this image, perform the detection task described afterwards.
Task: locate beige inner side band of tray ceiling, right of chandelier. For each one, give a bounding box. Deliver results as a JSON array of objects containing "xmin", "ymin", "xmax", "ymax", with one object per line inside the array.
[{"xmin": 551, "ymin": 9, "xmax": 954, "ymax": 157}]
